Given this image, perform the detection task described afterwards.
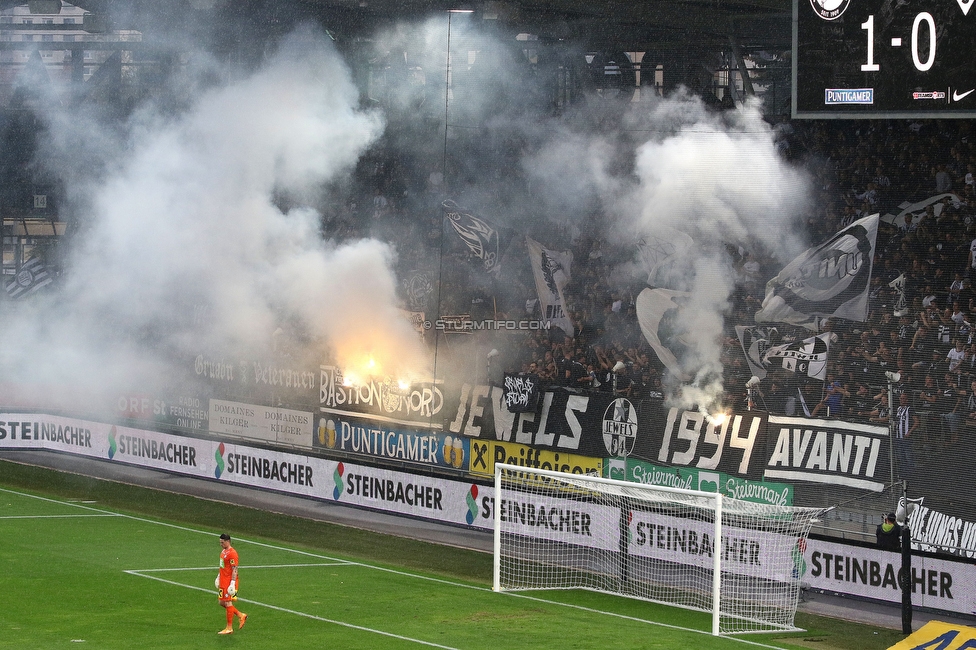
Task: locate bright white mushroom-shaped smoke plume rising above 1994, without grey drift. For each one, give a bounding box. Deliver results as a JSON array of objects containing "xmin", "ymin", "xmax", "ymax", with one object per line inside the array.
[{"xmin": 623, "ymin": 94, "xmax": 808, "ymax": 408}]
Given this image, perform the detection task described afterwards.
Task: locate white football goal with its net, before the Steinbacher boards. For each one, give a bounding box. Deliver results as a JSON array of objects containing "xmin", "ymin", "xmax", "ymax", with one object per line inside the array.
[{"xmin": 494, "ymin": 464, "xmax": 824, "ymax": 635}]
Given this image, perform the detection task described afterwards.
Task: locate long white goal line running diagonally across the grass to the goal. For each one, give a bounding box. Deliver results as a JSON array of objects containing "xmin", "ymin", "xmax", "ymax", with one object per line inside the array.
[{"xmin": 0, "ymin": 488, "xmax": 800, "ymax": 650}]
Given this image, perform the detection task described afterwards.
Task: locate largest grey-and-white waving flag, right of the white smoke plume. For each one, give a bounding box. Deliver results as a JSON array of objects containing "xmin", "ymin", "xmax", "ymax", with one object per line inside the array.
[{"xmin": 756, "ymin": 214, "xmax": 879, "ymax": 324}]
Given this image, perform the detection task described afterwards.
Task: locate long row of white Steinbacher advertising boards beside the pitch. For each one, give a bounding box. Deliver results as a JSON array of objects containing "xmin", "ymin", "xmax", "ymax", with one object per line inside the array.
[{"xmin": 0, "ymin": 413, "xmax": 976, "ymax": 614}]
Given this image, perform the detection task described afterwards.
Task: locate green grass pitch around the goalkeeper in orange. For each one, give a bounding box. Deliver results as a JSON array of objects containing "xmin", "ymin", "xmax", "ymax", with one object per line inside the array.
[{"xmin": 0, "ymin": 461, "xmax": 901, "ymax": 650}]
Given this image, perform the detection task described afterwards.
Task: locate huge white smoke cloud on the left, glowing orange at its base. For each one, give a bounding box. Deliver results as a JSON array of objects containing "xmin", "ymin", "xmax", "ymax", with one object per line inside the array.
[{"xmin": 2, "ymin": 30, "xmax": 424, "ymax": 400}]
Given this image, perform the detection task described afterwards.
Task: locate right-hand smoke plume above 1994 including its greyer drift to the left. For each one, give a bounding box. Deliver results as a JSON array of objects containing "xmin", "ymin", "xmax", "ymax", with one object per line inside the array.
[{"xmin": 526, "ymin": 91, "xmax": 809, "ymax": 408}]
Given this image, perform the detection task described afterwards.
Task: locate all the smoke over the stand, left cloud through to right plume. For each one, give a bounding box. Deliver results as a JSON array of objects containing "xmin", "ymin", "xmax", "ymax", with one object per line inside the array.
[{"xmin": 2, "ymin": 15, "xmax": 808, "ymax": 416}]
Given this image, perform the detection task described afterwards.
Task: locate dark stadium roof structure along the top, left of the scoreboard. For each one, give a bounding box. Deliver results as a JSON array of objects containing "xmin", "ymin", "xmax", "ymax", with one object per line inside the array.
[{"xmin": 0, "ymin": 0, "xmax": 792, "ymax": 56}]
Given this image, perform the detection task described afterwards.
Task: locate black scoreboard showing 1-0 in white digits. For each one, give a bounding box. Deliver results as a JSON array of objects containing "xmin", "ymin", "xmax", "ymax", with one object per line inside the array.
[{"xmin": 793, "ymin": 0, "xmax": 976, "ymax": 118}]
